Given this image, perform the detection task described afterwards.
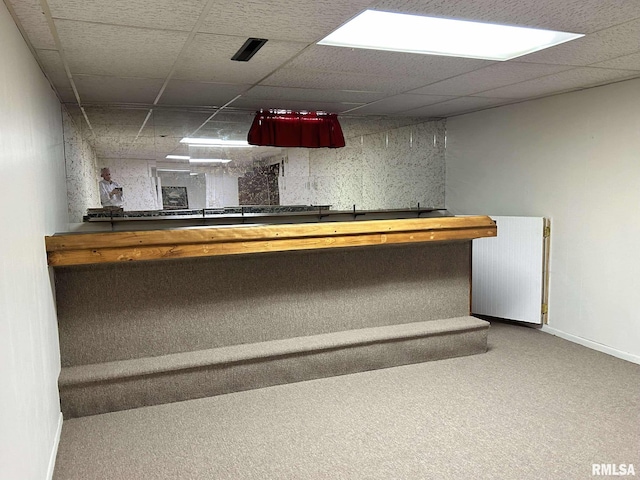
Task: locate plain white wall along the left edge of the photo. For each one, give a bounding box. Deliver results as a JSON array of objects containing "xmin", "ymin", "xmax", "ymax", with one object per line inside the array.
[{"xmin": 0, "ymin": 2, "xmax": 68, "ymax": 480}]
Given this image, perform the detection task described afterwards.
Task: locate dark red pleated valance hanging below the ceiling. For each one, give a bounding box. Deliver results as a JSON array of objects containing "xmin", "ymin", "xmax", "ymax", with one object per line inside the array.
[{"xmin": 247, "ymin": 111, "xmax": 345, "ymax": 148}]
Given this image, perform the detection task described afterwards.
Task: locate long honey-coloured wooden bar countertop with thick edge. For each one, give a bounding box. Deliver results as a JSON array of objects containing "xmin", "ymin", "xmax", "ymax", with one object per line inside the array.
[{"xmin": 45, "ymin": 216, "xmax": 497, "ymax": 267}]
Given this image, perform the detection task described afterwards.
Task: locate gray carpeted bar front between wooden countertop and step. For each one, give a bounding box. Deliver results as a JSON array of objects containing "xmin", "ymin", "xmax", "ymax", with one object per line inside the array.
[{"xmin": 55, "ymin": 242, "xmax": 471, "ymax": 367}]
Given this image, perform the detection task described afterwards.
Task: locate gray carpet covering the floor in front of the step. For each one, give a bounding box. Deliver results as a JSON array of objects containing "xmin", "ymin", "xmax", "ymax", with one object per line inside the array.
[{"xmin": 54, "ymin": 322, "xmax": 640, "ymax": 480}]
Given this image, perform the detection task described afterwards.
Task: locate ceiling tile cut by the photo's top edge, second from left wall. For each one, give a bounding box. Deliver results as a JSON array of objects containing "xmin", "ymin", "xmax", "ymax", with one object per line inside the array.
[{"xmin": 48, "ymin": 0, "xmax": 207, "ymax": 31}]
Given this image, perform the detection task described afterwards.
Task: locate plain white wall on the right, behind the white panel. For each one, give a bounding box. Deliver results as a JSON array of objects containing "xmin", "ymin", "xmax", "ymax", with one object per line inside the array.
[{"xmin": 446, "ymin": 80, "xmax": 640, "ymax": 363}]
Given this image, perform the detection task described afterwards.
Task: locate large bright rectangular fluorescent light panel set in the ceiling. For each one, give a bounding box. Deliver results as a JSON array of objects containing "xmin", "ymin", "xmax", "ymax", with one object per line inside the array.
[{"xmin": 318, "ymin": 10, "xmax": 584, "ymax": 61}]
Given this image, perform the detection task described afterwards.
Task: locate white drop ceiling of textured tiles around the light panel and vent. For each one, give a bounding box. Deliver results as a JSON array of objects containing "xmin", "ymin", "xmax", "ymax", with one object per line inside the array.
[{"xmin": 4, "ymin": 0, "xmax": 640, "ymax": 160}]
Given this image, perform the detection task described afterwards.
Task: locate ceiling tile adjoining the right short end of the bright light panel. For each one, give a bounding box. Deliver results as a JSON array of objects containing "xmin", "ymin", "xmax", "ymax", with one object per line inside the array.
[{"xmin": 518, "ymin": 18, "xmax": 640, "ymax": 66}]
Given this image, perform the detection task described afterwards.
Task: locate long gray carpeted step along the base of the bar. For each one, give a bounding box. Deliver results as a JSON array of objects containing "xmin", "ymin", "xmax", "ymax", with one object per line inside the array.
[{"xmin": 59, "ymin": 317, "xmax": 489, "ymax": 418}]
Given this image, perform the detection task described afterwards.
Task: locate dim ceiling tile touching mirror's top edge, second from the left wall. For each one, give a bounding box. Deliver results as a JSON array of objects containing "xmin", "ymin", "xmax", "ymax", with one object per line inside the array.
[{"xmin": 74, "ymin": 75, "xmax": 163, "ymax": 104}]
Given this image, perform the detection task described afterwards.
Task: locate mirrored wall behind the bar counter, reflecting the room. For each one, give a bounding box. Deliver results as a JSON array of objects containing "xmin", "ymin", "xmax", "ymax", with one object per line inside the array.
[{"xmin": 65, "ymin": 106, "xmax": 445, "ymax": 222}]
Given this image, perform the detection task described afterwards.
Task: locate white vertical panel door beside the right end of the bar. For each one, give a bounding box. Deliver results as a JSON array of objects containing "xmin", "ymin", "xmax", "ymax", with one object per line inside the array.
[{"xmin": 471, "ymin": 216, "xmax": 544, "ymax": 324}]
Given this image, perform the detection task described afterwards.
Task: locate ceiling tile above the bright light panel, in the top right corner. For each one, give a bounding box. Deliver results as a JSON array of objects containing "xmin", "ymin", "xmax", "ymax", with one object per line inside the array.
[{"xmin": 376, "ymin": 0, "xmax": 640, "ymax": 33}]
